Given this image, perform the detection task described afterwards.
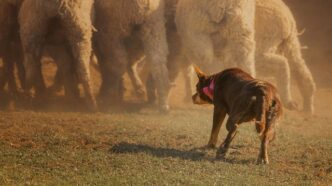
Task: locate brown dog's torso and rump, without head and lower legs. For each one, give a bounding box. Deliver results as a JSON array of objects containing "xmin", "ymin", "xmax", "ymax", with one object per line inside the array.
[{"xmin": 216, "ymin": 68, "xmax": 282, "ymax": 140}]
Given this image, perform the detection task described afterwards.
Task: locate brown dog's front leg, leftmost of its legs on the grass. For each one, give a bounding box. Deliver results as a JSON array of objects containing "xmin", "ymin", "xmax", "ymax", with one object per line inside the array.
[{"xmin": 207, "ymin": 106, "xmax": 226, "ymax": 148}]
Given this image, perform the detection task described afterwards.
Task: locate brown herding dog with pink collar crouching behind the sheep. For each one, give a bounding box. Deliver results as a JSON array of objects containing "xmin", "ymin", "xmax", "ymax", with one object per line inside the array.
[{"xmin": 192, "ymin": 67, "xmax": 282, "ymax": 164}]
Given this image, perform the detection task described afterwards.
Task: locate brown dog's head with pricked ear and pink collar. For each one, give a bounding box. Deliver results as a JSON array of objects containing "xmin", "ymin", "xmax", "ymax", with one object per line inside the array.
[{"xmin": 192, "ymin": 66, "xmax": 214, "ymax": 105}]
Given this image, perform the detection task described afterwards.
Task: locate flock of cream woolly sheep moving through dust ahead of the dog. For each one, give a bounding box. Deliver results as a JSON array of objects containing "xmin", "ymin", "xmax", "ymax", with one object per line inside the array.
[{"xmin": 0, "ymin": 0, "xmax": 315, "ymax": 113}]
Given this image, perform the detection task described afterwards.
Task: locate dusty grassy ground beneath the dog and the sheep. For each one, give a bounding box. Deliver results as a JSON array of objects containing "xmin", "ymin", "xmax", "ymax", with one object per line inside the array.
[{"xmin": 0, "ymin": 62, "xmax": 332, "ymax": 185}]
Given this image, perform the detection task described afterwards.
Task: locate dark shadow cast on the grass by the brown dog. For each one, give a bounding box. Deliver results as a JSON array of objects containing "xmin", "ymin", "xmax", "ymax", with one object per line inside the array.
[{"xmin": 110, "ymin": 142, "xmax": 205, "ymax": 161}]
